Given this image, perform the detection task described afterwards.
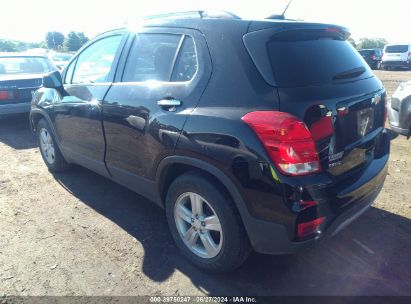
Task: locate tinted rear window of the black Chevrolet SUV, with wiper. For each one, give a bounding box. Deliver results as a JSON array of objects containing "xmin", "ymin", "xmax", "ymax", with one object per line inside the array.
[{"xmin": 268, "ymin": 37, "xmax": 372, "ymax": 87}]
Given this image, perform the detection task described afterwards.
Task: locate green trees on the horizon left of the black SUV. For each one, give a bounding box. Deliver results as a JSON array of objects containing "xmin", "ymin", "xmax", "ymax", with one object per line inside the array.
[{"xmin": 0, "ymin": 31, "xmax": 89, "ymax": 52}]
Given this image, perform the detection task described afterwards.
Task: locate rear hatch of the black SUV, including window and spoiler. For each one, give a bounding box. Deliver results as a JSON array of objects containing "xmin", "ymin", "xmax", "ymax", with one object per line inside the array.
[{"xmin": 243, "ymin": 22, "xmax": 386, "ymax": 182}]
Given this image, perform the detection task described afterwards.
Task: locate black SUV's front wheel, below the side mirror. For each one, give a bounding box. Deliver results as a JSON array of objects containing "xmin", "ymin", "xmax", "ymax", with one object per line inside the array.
[{"xmin": 37, "ymin": 118, "xmax": 69, "ymax": 172}]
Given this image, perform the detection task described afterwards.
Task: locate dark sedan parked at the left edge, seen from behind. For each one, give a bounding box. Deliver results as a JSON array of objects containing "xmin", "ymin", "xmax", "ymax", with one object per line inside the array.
[{"xmin": 0, "ymin": 53, "xmax": 56, "ymax": 116}]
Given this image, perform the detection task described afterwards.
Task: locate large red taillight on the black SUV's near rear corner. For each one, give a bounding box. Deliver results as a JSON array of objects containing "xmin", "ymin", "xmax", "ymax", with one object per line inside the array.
[{"xmin": 242, "ymin": 111, "xmax": 321, "ymax": 175}]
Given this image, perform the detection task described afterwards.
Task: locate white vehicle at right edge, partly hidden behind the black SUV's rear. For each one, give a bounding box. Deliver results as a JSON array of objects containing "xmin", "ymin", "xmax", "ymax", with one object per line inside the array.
[{"xmin": 388, "ymin": 81, "xmax": 411, "ymax": 139}]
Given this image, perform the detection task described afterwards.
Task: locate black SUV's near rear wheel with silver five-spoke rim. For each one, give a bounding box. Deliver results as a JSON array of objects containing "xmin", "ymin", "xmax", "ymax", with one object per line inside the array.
[{"xmin": 166, "ymin": 173, "xmax": 251, "ymax": 273}]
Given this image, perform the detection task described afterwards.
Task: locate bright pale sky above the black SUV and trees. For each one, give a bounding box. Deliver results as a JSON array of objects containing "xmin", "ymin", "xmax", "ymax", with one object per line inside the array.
[{"xmin": 0, "ymin": 0, "xmax": 411, "ymax": 43}]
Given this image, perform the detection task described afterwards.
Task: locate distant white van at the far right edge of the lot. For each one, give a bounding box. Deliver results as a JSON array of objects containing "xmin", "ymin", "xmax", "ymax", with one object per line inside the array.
[{"xmin": 382, "ymin": 44, "xmax": 411, "ymax": 70}]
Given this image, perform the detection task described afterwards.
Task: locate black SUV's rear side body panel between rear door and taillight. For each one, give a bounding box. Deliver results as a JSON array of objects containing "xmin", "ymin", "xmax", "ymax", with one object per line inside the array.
[{"xmin": 175, "ymin": 23, "xmax": 295, "ymax": 234}]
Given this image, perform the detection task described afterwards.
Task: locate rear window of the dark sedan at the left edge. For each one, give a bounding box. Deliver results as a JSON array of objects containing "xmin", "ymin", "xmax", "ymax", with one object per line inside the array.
[{"xmin": 0, "ymin": 57, "xmax": 55, "ymax": 75}]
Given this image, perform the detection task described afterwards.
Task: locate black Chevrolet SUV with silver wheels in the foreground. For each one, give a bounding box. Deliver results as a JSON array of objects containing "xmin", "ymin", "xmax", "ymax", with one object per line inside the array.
[{"xmin": 30, "ymin": 11, "xmax": 389, "ymax": 272}]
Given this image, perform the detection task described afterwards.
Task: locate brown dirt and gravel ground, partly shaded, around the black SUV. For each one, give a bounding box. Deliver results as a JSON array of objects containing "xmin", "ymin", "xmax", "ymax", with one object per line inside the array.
[{"xmin": 0, "ymin": 71, "xmax": 411, "ymax": 296}]
